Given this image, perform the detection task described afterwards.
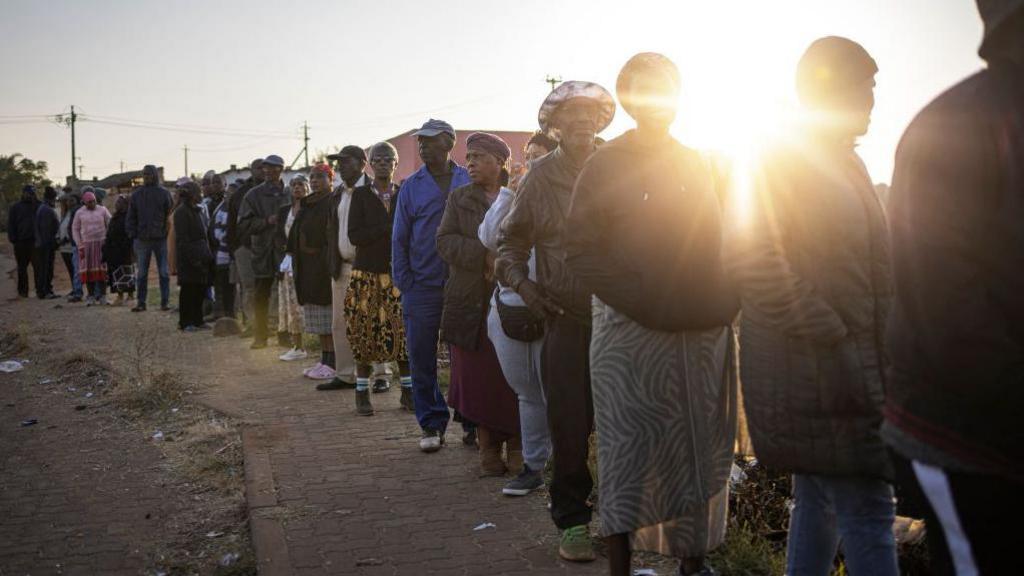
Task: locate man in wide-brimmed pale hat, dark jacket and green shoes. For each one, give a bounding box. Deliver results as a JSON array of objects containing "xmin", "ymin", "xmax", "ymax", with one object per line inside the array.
[{"xmin": 497, "ymin": 81, "xmax": 615, "ymax": 562}]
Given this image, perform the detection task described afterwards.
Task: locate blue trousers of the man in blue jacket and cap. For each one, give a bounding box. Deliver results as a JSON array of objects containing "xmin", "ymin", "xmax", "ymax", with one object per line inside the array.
[{"xmin": 401, "ymin": 288, "xmax": 451, "ymax": 434}]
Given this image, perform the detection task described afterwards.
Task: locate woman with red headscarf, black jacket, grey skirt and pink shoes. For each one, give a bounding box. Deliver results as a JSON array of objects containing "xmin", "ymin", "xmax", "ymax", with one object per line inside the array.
[{"xmin": 288, "ymin": 164, "xmax": 334, "ymax": 368}]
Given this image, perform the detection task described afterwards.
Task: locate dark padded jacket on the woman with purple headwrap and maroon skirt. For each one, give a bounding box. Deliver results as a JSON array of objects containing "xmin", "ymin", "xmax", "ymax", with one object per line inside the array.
[{"xmin": 437, "ymin": 184, "xmax": 495, "ymax": 349}]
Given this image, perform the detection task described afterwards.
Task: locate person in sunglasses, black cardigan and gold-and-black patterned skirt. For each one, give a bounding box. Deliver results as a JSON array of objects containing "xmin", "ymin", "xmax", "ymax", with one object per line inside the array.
[{"xmin": 345, "ymin": 142, "xmax": 414, "ymax": 416}]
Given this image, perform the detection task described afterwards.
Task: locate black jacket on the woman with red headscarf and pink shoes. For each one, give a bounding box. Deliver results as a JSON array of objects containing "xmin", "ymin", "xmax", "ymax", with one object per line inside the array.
[{"xmin": 286, "ymin": 194, "xmax": 332, "ymax": 306}]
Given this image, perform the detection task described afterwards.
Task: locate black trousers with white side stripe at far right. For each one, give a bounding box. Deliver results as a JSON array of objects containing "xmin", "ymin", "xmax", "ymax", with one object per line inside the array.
[{"xmin": 893, "ymin": 453, "xmax": 1024, "ymax": 576}]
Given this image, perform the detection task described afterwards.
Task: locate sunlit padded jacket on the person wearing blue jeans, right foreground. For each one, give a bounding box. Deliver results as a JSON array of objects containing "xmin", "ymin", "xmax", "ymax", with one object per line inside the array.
[{"xmin": 727, "ymin": 137, "xmax": 892, "ymax": 479}]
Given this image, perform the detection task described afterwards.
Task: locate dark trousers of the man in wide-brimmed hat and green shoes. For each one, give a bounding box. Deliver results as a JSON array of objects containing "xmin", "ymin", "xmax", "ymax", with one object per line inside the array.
[{"xmin": 541, "ymin": 316, "xmax": 594, "ymax": 530}]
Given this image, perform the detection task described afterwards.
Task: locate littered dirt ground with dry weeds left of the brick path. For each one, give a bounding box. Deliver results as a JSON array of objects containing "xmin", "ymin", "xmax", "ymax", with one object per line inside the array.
[{"xmin": 0, "ymin": 248, "xmax": 255, "ymax": 576}]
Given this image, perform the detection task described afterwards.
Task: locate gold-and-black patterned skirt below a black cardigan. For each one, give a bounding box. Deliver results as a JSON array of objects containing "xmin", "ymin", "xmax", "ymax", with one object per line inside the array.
[{"xmin": 345, "ymin": 270, "xmax": 409, "ymax": 364}]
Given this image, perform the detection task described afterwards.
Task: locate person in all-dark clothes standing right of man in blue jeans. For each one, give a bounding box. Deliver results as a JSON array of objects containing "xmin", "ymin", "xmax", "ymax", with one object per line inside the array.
[{"xmin": 171, "ymin": 180, "xmax": 213, "ymax": 332}]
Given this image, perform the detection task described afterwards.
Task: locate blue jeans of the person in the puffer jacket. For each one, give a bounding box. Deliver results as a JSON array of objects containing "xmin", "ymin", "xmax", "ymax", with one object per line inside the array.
[{"xmin": 785, "ymin": 474, "xmax": 899, "ymax": 576}]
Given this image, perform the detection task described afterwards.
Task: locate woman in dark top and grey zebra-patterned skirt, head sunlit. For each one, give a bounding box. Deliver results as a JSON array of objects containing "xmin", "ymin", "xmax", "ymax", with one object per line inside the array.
[{"xmin": 565, "ymin": 53, "xmax": 738, "ymax": 575}]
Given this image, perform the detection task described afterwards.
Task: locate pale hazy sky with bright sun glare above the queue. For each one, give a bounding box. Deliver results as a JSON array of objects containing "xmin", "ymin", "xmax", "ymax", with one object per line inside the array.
[{"xmin": 0, "ymin": 0, "xmax": 983, "ymax": 182}]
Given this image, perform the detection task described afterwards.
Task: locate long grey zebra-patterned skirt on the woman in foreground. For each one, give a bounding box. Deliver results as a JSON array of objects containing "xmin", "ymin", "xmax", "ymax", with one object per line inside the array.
[{"xmin": 590, "ymin": 298, "xmax": 738, "ymax": 558}]
